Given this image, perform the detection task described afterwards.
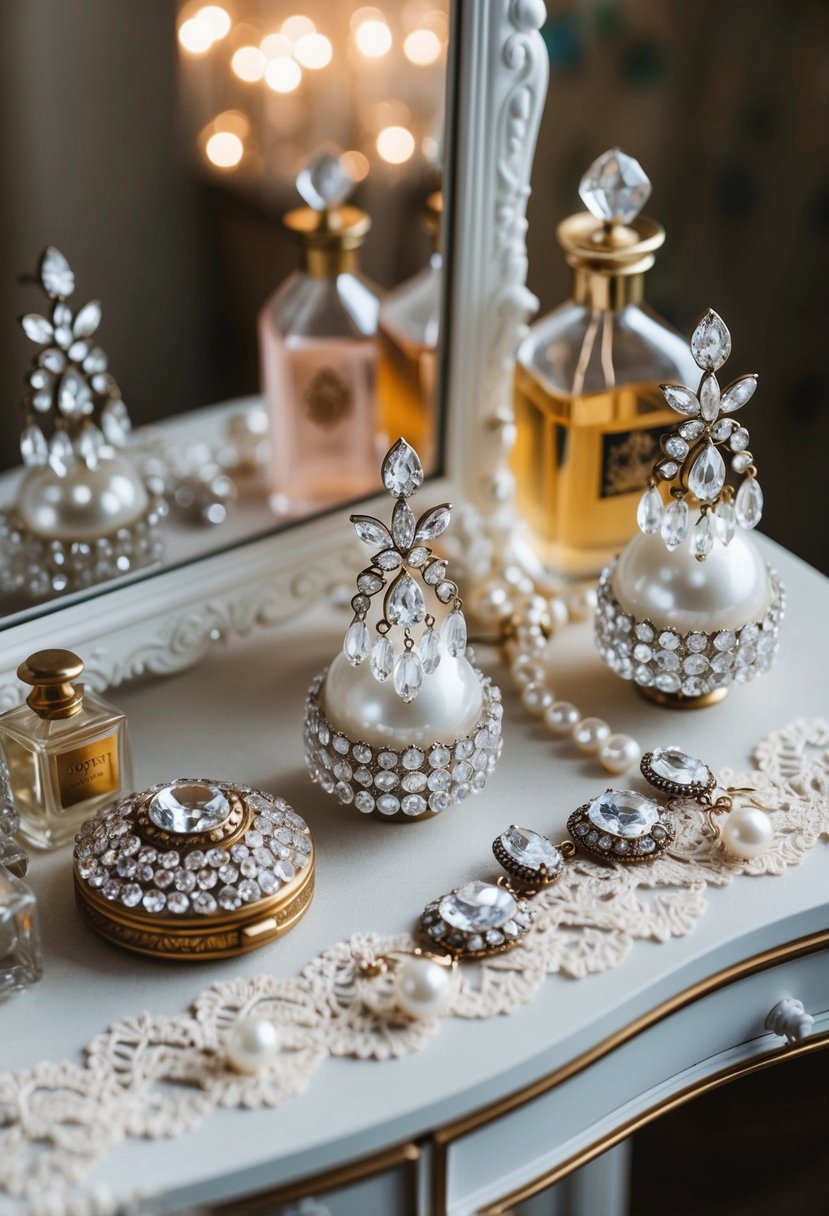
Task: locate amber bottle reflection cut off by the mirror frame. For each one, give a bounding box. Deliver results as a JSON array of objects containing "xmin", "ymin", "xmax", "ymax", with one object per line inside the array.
[{"xmin": 378, "ymin": 191, "xmax": 442, "ymax": 473}]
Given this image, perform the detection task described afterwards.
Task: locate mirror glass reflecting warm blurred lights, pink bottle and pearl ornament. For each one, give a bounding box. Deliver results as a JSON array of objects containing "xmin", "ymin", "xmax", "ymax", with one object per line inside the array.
[{"xmin": 0, "ymin": 0, "xmax": 449, "ymax": 626}]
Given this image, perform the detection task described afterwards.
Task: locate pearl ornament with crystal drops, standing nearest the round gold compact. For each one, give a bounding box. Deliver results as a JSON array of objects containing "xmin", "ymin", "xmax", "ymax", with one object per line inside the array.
[{"xmin": 305, "ymin": 439, "xmax": 503, "ymax": 820}]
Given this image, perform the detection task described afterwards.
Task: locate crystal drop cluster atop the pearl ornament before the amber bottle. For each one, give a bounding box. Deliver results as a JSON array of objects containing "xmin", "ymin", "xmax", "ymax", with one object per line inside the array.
[{"xmin": 637, "ymin": 309, "xmax": 763, "ymax": 562}]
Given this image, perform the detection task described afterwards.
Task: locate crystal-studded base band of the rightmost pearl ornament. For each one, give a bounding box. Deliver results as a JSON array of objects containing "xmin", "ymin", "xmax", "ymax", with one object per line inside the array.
[{"xmin": 596, "ymin": 562, "xmax": 785, "ymax": 697}]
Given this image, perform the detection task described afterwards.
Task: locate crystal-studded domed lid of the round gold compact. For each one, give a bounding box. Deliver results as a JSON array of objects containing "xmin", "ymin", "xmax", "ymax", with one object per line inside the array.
[{"xmin": 73, "ymin": 777, "xmax": 312, "ymax": 917}]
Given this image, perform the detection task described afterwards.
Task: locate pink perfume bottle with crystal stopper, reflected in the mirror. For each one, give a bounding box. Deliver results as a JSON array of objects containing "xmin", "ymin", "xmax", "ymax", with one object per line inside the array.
[{"xmin": 259, "ymin": 152, "xmax": 383, "ymax": 516}]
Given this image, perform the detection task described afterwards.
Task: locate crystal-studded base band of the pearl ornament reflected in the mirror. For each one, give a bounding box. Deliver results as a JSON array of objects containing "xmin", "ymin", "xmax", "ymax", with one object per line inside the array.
[{"xmin": 0, "ymin": 495, "xmax": 168, "ymax": 599}]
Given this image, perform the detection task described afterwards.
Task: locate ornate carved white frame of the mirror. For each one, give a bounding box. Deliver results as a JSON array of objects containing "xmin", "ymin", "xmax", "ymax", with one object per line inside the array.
[{"xmin": 0, "ymin": 0, "xmax": 547, "ymax": 709}]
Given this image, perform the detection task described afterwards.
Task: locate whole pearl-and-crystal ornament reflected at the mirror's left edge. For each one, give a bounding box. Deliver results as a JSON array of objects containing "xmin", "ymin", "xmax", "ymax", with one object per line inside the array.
[{"xmin": 0, "ymin": 246, "xmax": 167, "ymax": 598}]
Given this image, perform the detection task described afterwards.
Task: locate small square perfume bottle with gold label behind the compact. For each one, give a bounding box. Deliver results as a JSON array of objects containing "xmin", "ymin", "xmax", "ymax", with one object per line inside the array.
[{"xmin": 0, "ymin": 651, "xmax": 132, "ymax": 849}]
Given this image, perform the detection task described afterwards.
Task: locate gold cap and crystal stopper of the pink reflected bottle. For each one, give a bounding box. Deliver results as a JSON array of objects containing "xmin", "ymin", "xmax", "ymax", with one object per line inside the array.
[{"xmin": 282, "ymin": 151, "xmax": 371, "ymax": 278}]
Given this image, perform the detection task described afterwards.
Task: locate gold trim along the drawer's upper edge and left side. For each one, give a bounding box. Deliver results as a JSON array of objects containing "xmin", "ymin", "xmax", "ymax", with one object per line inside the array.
[{"xmin": 430, "ymin": 929, "xmax": 829, "ymax": 1216}]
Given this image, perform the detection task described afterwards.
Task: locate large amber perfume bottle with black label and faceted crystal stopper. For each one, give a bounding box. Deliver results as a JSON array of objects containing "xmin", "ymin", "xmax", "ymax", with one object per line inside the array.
[{"xmin": 513, "ymin": 148, "xmax": 695, "ymax": 578}]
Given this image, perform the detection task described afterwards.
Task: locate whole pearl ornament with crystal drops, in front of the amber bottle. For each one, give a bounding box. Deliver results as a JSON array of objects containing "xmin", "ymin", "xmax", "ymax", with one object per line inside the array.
[{"xmin": 596, "ymin": 310, "xmax": 784, "ymax": 706}]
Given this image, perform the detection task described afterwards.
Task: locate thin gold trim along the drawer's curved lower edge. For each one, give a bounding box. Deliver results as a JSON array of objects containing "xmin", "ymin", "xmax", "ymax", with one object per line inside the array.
[{"xmin": 478, "ymin": 1030, "xmax": 829, "ymax": 1216}]
